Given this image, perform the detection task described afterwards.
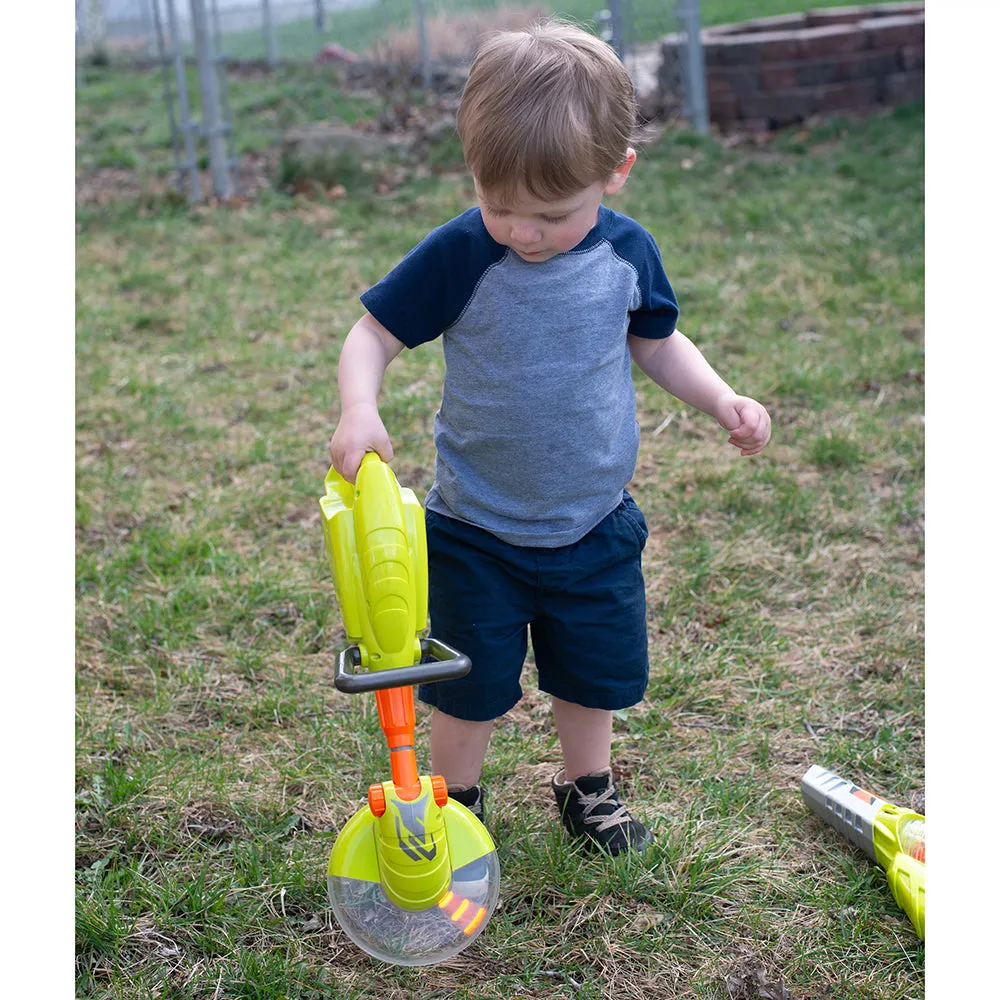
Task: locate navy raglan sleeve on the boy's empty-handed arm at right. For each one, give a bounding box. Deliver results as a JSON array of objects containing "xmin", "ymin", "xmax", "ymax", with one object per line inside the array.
[{"xmin": 596, "ymin": 206, "xmax": 680, "ymax": 340}]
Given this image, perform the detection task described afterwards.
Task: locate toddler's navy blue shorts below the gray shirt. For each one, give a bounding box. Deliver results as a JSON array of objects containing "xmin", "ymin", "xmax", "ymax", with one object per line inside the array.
[{"xmin": 418, "ymin": 493, "xmax": 649, "ymax": 722}]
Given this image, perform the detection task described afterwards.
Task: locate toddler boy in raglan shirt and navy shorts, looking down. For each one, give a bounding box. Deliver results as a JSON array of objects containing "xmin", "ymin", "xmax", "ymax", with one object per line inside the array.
[{"xmin": 330, "ymin": 21, "xmax": 770, "ymax": 854}]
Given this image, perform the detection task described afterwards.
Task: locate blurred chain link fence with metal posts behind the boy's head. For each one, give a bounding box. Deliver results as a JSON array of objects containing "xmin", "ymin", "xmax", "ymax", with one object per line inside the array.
[{"xmin": 76, "ymin": 0, "xmax": 708, "ymax": 200}]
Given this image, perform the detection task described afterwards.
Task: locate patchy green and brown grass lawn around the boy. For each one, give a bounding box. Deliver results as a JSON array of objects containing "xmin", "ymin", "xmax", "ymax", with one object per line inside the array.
[{"xmin": 76, "ymin": 56, "xmax": 924, "ymax": 1000}]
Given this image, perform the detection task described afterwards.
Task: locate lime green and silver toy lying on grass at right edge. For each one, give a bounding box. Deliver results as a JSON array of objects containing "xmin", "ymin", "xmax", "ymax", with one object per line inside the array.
[{"xmin": 802, "ymin": 764, "xmax": 925, "ymax": 940}]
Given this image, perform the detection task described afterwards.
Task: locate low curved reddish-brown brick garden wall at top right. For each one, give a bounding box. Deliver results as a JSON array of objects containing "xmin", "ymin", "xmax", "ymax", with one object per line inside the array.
[{"xmin": 660, "ymin": 3, "xmax": 924, "ymax": 129}]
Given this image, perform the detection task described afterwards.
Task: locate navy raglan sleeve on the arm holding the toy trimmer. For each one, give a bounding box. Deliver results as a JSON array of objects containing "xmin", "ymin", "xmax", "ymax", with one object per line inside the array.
[{"xmin": 361, "ymin": 208, "xmax": 507, "ymax": 347}]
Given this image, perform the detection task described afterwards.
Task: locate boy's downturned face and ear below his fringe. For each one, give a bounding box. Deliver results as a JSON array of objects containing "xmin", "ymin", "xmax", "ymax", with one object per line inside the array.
[{"xmin": 476, "ymin": 149, "xmax": 635, "ymax": 264}]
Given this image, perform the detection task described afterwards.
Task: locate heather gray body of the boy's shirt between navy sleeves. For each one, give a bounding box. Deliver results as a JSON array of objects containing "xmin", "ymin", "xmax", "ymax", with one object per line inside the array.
[{"xmin": 426, "ymin": 240, "xmax": 640, "ymax": 548}]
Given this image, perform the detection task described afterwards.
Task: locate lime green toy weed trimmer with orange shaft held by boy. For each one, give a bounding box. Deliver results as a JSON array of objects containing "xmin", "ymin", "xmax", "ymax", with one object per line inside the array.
[{"xmin": 319, "ymin": 453, "xmax": 500, "ymax": 965}]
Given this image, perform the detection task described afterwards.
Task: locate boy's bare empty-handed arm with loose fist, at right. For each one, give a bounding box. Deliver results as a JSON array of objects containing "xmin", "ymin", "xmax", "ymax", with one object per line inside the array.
[{"xmin": 628, "ymin": 330, "xmax": 771, "ymax": 455}]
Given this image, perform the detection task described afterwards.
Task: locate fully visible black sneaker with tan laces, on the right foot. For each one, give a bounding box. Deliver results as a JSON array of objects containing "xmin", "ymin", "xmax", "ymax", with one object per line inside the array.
[{"xmin": 552, "ymin": 767, "xmax": 653, "ymax": 854}]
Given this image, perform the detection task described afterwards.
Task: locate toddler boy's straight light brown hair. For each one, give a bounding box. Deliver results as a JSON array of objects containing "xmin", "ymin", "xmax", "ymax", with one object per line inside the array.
[{"xmin": 458, "ymin": 20, "xmax": 637, "ymax": 204}]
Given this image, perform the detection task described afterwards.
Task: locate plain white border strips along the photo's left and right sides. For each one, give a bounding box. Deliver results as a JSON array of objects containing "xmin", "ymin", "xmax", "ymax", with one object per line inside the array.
[{"xmin": 0, "ymin": 0, "xmax": 1000, "ymax": 1000}]
